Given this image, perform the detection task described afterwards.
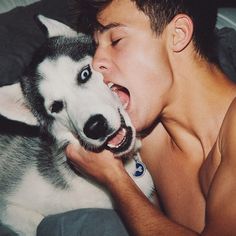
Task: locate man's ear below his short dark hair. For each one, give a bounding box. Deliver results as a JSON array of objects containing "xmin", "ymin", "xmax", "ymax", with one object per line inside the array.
[{"xmin": 171, "ymin": 14, "xmax": 193, "ymax": 52}]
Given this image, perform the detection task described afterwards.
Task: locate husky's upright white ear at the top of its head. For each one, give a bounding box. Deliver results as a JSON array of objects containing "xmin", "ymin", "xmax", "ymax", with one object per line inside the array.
[{"xmin": 37, "ymin": 15, "xmax": 78, "ymax": 38}]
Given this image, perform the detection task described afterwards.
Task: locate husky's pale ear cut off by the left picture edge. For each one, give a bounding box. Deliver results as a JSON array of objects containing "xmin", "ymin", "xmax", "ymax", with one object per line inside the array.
[{"xmin": 0, "ymin": 83, "xmax": 39, "ymax": 126}]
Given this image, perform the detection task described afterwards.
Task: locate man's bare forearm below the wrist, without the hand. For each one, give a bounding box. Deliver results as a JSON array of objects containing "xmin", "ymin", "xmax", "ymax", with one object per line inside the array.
[{"xmin": 104, "ymin": 168, "xmax": 198, "ymax": 236}]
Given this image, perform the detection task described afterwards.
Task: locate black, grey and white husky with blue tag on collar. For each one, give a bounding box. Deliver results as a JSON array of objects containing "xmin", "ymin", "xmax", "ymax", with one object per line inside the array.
[{"xmin": 0, "ymin": 15, "xmax": 153, "ymax": 236}]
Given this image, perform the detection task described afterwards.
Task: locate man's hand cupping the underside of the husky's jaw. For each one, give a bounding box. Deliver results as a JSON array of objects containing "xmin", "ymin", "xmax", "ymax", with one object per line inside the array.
[{"xmin": 66, "ymin": 144, "xmax": 127, "ymax": 185}]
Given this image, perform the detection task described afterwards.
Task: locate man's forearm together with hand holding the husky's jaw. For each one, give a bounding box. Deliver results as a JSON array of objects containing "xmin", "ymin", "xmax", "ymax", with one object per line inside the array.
[{"xmin": 67, "ymin": 146, "xmax": 198, "ymax": 236}]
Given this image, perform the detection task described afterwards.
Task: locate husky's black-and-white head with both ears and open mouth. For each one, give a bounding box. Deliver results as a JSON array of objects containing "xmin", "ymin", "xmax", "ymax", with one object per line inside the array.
[{"xmin": 0, "ymin": 16, "xmax": 136, "ymax": 155}]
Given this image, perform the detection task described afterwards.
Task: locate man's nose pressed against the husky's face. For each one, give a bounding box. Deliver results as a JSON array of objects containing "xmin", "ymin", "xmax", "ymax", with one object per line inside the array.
[{"xmin": 92, "ymin": 49, "xmax": 111, "ymax": 74}]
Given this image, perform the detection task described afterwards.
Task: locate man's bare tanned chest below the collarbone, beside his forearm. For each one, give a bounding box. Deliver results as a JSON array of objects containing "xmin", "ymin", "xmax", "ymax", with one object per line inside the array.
[{"xmin": 143, "ymin": 125, "xmax": 222, "ymax": 232}]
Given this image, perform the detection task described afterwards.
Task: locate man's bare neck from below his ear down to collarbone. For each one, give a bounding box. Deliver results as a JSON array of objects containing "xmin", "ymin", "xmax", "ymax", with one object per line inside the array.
[{"xmin": 161, "ymin": 54, "xmax": 236, "ymax": 155}]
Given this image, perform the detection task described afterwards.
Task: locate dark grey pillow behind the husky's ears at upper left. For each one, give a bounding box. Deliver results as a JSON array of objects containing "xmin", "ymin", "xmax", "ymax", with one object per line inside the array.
[{"xmin": 0, "ymin": 0, "xmax": 68, "ymax": 86}]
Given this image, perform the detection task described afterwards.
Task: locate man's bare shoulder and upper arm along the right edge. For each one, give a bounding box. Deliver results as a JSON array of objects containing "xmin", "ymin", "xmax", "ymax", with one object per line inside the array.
[{"xmin": 202, "ymin": 99, "xmax": 236, "ymax": 235}]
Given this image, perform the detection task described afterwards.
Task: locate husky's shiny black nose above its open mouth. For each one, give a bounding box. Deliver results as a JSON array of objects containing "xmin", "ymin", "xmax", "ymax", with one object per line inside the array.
[{"xmin": 84, "ymin": 114, "xmax": 108, "ymax": 139}]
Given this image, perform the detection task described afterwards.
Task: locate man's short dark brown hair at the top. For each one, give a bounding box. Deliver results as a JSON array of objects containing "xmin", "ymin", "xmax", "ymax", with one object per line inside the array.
[{"xmin": 69, "ymin": 0, "xmax": 217, "ymax": 62}]
